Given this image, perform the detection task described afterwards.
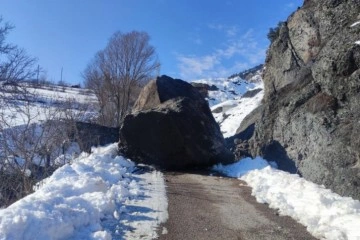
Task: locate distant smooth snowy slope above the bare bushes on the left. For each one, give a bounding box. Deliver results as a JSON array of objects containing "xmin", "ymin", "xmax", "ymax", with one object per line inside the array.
[{"xmin": 0, "ymin": 83, "xmax": 97, "ymax": 127}]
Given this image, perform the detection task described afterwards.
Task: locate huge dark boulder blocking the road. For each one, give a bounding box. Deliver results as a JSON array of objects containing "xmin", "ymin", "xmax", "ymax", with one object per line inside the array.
[{"xmin": 119, "ymin": 76, "xmax": 233, "ymax": 170}]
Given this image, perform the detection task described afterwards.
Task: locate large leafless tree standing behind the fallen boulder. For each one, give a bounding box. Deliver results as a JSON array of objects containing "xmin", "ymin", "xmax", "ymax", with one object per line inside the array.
[{"xmin": 83, "ymin": 31, "xmax": 160, "ymax": 127}]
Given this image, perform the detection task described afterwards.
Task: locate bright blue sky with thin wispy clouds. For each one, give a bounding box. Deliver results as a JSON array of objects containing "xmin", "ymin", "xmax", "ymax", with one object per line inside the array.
[{"xmin": 0, "ymin": 0, "xmax": 303, "ymax": 83}]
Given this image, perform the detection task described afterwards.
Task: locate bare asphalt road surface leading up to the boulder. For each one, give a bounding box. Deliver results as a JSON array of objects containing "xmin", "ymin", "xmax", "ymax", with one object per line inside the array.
[{"xmin": 158, "ymin": 173, "xmax": 316, "ymax": 240}]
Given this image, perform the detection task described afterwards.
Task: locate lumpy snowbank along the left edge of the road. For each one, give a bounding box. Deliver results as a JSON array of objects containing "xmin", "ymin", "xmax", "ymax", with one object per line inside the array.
[{"xmin": 0, "ymin": 144, "xmax": 168, "ymax": 240}]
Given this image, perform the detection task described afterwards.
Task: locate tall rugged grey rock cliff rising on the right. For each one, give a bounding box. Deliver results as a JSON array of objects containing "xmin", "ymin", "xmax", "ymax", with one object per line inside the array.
[{"xmin": 239, "ymin": 0, "xmax": 360, "ymax": 199}]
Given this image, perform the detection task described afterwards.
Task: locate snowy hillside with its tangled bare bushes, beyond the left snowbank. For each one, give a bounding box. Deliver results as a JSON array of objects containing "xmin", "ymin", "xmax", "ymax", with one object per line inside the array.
[{"xmin": 0, "ymin": 83, "xmax": 98, "ymax": 207}]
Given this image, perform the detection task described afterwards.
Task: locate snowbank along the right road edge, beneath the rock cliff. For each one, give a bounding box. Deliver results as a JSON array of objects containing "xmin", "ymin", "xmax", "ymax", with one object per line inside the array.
[{"xmin": 214, "ymin": 157, "xmax": 360, "ymax": 240}]
